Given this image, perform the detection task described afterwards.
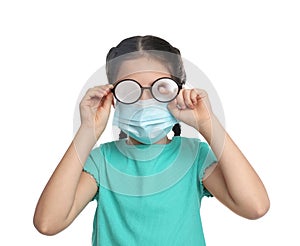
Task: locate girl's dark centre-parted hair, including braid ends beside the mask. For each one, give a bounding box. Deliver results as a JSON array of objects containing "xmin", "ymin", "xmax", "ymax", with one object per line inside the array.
[{"xmin": 106, "ymin": 35, "xmax": 186, "ymax": 138}]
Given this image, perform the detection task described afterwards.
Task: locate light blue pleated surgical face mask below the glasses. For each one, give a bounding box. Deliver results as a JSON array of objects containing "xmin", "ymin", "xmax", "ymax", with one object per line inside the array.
[{"xmin": 113, "ymin": 99, "xmax": 178, "ymax": 144}]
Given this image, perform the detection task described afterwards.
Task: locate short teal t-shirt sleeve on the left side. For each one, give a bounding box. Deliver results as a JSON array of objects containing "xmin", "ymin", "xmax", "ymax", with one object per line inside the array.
[{"xmin": 83, "ymin": 147, "xmax": 103, "ymax": 200}]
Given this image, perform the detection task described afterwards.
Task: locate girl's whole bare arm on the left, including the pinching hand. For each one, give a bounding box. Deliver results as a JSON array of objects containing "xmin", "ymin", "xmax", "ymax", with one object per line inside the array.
[{"xmin": 33, "ymin": 85, "xmax": 112, "ymax": 235}]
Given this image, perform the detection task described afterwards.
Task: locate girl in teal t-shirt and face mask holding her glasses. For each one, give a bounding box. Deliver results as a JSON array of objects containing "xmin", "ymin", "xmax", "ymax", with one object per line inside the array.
[{"xmin": 34, "ymin": 36, "xmax": 269, "ymax": 246}]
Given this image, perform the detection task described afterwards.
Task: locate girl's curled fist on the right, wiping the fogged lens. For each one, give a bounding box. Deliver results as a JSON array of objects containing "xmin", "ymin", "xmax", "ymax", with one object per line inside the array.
[{"xmin": 168, "ymin": 88, "xmax": 213, "ymax": 132}]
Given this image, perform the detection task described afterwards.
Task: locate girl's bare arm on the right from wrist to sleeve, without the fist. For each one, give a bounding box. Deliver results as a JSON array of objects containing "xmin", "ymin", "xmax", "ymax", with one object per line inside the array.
[{"xmin": 201, "ymin": 117, "xmax": 270, "ymax": 219}]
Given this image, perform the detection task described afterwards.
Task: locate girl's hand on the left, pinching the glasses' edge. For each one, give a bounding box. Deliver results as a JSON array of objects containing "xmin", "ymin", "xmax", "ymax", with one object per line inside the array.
[{"xmin": 80, "ymin": 84, "xmax": 113, "ymax": 140}]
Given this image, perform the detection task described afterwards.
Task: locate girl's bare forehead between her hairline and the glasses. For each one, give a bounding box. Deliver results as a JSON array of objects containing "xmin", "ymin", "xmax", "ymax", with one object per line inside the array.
[{"xmin": 117, "ymin": 56, "xmax": 170, "ymax": 80}]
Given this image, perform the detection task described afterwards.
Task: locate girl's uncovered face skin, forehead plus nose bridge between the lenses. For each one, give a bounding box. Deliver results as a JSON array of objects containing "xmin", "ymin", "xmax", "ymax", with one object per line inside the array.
[{"xmin": 117, "ymin": 57, "xmax": 171, "ymax": 100}]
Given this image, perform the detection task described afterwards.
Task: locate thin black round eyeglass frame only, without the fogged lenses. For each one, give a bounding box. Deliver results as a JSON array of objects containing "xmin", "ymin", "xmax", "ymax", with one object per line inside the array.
[{"xmin": 111, "ymin": 77, "xmax": 182, "ymax": 104}]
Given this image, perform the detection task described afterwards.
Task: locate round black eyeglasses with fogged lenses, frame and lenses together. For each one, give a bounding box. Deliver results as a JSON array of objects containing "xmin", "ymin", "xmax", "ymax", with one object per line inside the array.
[{"xmin": 111, "ymin": 77, "xmax": 182, "ymax": 104}]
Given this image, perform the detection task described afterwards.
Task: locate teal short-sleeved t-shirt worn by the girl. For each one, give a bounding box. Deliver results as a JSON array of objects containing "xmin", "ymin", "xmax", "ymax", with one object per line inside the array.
[{"xmin": 84, "ymin": 137, "xmax": 216, "ymax": 246}]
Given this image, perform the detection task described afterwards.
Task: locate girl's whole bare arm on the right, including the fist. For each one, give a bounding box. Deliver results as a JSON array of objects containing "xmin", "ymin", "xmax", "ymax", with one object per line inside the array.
[{"xmin": 169, "ymin": 89, "xmax": 270, "ymax": 219}]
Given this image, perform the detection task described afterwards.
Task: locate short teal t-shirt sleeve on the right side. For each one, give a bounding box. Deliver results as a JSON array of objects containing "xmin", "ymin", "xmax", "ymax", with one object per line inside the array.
[{"xmin": 198, "ymin": 142, "xmax": 217, "ymax": 197}]
